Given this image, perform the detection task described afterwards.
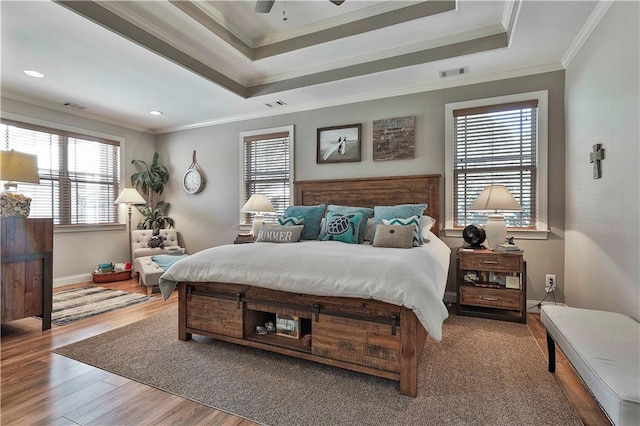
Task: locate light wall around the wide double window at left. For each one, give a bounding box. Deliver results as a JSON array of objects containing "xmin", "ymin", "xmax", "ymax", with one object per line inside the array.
[{"xmin": 2, "ymin": 98, "xmax": 154, "ymax": 287}]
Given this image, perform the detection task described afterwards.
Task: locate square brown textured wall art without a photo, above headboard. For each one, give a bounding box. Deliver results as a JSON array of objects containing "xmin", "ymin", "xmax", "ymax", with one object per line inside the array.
[{"xmin": 373, "ymin": 117, "xmax": 416, "ymax": 161}]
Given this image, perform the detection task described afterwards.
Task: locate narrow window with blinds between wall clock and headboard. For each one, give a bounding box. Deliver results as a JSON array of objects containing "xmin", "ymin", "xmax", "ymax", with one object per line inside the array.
[{"xmin": 240, "ymin": 126, "xmax": 293, "ymax": 224}]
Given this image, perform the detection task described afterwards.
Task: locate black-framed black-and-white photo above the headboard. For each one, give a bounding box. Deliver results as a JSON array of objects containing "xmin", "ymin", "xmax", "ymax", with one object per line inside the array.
[{"xmin": 316, "ymin": 124, "xmax": 362, "ymax": 164}]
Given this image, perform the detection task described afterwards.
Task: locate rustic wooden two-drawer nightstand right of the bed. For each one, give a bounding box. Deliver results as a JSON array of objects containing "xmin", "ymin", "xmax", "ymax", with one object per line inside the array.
[{"xmin": 456, "ymin": 249, "xmax": 527, "ymax": 324}]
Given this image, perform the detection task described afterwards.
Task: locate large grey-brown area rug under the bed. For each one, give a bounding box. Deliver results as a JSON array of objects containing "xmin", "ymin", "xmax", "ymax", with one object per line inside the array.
[{"xmin": 54, "ymin": 311, "xmax": 582, "ymax": 425}]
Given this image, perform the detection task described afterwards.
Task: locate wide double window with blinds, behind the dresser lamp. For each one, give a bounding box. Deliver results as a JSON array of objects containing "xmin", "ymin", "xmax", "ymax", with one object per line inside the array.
[{"xmin": 0, "ymin": 120, "xmax": 120, "ymax": 225}]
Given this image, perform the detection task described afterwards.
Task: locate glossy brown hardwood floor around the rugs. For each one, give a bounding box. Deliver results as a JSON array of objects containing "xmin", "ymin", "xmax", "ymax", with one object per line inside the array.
[{"xmin": 0, "ymin": 280, "xmax": 610, "ymax": 426}]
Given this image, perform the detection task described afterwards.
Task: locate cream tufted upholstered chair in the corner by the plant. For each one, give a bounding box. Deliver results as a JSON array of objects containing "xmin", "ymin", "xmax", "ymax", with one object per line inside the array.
[{"xmin": 131, "ymin": 229, "xmax": 184, "ymax": 294}]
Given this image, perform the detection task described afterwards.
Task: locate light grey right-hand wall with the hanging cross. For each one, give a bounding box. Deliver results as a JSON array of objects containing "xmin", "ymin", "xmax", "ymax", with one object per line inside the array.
[{"xmin": 565, "ymin": 2, "xmax": 640, "ymax": 320}]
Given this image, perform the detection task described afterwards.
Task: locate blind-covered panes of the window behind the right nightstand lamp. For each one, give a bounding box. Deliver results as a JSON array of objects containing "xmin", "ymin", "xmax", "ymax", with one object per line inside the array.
[{"xmin": 453, "ymin": 100, "xmax": 538, "ymax": 229}]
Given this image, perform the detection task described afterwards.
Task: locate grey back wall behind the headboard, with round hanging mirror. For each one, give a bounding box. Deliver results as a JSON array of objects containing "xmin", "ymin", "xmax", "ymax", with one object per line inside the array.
[{"xmin": 156, "ymin": 71, "xmax": 565, "ymax": 300}]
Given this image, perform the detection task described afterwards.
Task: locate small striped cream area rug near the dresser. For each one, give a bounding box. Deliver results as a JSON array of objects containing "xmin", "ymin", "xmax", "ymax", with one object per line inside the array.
[{"xmin": 51, "ymin": 286, "xmax": 155, "ymax": 325}]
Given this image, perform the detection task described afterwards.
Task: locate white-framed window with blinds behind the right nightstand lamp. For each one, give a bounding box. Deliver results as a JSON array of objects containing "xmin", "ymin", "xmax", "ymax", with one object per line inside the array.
[{"xmin": 446, "ymin": 91, "xmax": 547, "ymax": 238}]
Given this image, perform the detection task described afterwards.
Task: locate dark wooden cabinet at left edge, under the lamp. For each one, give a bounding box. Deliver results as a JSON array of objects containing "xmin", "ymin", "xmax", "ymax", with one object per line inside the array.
[{"xmin": 0, "ymin": 217, "xmax": 53, "ymax": 330}]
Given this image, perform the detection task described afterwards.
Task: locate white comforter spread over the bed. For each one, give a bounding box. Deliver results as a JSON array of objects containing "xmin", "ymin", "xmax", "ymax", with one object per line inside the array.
[{"xmin": 159, "ymin": 234, "xmax": 451, "ymax": 341}]
